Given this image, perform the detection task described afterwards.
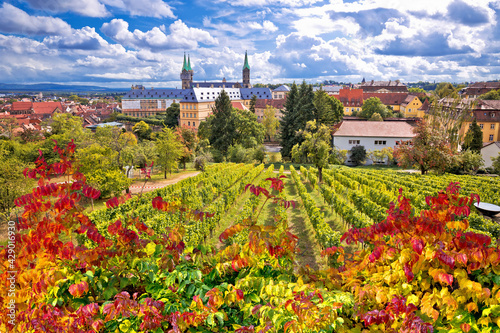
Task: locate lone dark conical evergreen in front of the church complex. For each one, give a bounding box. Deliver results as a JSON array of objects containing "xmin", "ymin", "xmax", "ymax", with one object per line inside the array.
[{"xmin": 209, "ymin": 90, "xmax": 236, "ymax": 156}]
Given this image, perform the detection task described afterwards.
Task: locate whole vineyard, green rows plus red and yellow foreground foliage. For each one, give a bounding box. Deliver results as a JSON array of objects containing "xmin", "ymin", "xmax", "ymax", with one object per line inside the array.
[{"xmin": 0, "ymin": 145, "xmax": 500, "ymax": 333}]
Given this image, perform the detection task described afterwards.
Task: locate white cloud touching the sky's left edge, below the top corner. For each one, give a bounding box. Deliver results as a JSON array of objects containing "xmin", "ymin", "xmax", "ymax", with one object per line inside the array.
[{"xmin": 0, "ymin": 2, "xmax": 71, "ymax": 35}]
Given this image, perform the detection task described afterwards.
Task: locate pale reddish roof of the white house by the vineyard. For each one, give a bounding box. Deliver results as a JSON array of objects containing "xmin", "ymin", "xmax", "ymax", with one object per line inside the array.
[{"xmin": 334, "ymin": 121, "xmax": 415, "ymax": 138}]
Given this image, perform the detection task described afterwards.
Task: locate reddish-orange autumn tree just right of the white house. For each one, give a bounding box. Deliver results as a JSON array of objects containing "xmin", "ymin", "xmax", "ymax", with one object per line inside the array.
[{"xmin": 394, "ymin": 119, "xmax": 453, "ymax": 174}]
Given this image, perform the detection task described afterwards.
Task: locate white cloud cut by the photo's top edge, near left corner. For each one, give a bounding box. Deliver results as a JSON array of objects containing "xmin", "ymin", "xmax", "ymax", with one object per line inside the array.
[{"xmin": 24, "ymin": 0, "xmax": 109, "ymax": 17}]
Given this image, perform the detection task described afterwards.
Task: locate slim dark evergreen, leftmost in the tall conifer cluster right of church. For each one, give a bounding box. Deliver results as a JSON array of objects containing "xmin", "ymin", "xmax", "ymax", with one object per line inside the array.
[{"xmin": 279, "ymin": 82, "xmax": 299, "ymax": 157}]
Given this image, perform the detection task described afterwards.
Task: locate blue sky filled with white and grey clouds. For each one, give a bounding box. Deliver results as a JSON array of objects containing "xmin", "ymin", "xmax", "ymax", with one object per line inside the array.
[{"xmin": 0, "ymin": 0, "xmax": 500, "ymax": 88}]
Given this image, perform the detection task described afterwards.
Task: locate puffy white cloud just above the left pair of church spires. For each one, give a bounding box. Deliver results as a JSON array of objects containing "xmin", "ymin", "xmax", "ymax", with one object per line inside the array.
[{"xmin": 101, "ymin": 19, "xmax": 218, "ymax": 51}]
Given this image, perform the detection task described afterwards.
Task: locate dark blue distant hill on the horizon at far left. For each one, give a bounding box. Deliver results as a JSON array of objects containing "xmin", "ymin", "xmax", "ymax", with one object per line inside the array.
[{"xmin": 0, "ymin": 83, "xmax": 130, "ymax": 93}]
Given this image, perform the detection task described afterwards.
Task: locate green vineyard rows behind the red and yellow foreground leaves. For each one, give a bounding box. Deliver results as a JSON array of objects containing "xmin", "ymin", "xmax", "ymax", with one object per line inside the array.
[{"xmin": 90, "ymin": 164, "xmax": 500, "ymax": 269}]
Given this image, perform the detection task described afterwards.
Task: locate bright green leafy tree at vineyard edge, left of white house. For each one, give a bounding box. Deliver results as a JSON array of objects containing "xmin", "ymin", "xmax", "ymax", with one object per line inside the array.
[{"xmin": 292, "ymin": 120, "xmax": 332, "ymax": 183}]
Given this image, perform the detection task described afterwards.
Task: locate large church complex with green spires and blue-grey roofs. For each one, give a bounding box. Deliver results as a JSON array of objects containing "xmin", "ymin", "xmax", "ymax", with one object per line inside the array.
[{"xmin": 122, "ymin": 52, "xmax": 272, "ymax": 130}]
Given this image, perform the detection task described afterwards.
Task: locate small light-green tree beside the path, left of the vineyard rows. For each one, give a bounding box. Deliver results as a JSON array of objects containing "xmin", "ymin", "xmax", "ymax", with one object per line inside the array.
[{"xmin": 155, "ymin": 127, "xmax": 183, "ymax": 179}]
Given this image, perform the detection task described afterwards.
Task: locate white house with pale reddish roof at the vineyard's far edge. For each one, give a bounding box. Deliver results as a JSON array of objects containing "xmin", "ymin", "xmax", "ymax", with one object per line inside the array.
[{"xmin": 333, "ymin": 120, "xmax": 415, "ymax": 165}]
